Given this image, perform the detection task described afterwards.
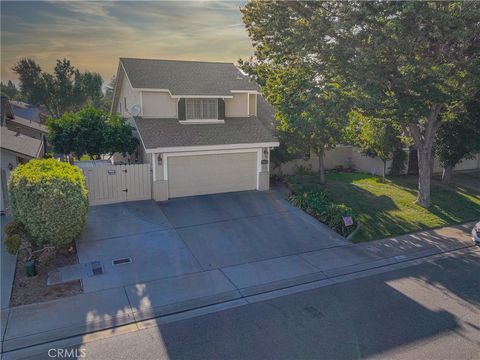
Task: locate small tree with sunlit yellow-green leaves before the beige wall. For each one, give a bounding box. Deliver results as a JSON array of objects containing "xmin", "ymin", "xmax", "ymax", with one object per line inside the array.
[{"xmin": 345, "ymin": 111, "xmax": 403, "ymax": 182}]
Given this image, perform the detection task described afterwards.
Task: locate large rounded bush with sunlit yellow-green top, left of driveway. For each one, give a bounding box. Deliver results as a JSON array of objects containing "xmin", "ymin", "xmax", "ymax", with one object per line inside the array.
[{"xmin": 8, "ymin": 159, "xmax": 88, "ymax": 248}]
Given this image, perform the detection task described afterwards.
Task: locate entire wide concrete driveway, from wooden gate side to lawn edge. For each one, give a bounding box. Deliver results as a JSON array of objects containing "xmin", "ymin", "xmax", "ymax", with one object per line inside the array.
[{"xmin": 77, "ymin": 191, "xmax": 348, "ymax": 292}]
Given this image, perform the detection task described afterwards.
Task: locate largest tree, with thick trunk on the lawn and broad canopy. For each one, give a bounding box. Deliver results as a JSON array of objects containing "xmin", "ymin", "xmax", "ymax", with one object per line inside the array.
[{"xmin": 242, "ymin": 0, "xmax": 480, "ymax": 207}]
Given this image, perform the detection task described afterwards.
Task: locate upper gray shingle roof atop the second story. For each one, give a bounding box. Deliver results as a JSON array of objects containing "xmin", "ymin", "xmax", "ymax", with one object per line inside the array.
[{"xmin": 120, "ymin": 58, "xmax": 258, "ymax": 96}]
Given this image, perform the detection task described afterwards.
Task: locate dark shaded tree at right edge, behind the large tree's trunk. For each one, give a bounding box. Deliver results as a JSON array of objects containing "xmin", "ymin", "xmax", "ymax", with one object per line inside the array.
[{"xmin": 435, "ymin": 92, "xmax": 480, "ymax": 184}]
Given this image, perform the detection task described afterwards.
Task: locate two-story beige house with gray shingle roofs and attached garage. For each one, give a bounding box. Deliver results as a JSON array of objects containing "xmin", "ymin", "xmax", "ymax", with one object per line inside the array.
[{"xmin": 112, "ymin": 58, "xmax": 279, "ymax": 201}]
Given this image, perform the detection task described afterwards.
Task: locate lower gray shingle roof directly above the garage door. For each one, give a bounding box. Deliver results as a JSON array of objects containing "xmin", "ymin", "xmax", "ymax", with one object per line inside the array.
[{"xmin": 137, "ymin": 117, "xmax": 277, "ymax": 149}]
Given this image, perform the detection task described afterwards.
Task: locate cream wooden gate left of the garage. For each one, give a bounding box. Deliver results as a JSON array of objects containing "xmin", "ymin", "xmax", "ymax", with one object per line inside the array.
[{"xmin": 82, "ymin": 164, "xmax": 152, "ymax": 205}]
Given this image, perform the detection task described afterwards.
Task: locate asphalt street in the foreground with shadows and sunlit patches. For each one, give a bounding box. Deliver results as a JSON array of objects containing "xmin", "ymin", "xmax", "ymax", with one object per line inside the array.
[{"xmin": 15, "ymin": 248, "xmax": 480, "ymax": 359}]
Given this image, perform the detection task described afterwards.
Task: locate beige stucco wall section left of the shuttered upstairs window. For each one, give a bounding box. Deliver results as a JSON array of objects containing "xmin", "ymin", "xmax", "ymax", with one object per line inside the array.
[{"xmin": 141, "ymin": 91, "xmax": 177, "ymax": 118}]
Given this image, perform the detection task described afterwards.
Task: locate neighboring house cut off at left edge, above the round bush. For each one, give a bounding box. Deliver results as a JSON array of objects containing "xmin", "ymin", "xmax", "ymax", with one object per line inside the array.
[{"xmin": 0, "ymin": 96, "xmax": 45, "ymax": 213}]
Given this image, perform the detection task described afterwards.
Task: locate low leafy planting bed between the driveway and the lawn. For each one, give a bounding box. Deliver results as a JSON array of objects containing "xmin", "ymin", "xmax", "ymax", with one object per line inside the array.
[{"xmin": 289, "ymin": 186, "xmax": 357, "ymax": 236}]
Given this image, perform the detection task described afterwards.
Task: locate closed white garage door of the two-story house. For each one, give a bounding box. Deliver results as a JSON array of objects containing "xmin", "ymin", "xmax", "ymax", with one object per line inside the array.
[{"xmin": 167, "ymin": 152, "xmax": 257, "ymax": 198}]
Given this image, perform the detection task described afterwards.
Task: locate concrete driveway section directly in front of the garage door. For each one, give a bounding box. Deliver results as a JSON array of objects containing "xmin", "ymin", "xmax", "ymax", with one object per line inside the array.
[{"xmin": 160, "ymin": 191, "xmax": 346, "ymax": 270}]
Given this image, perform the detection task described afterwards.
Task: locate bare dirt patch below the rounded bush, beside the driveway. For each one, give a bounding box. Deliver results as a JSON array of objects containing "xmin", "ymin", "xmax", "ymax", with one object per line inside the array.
[{"xmin": 10, "ymin": 245, "xmax": 83, "ymax": 307}]
